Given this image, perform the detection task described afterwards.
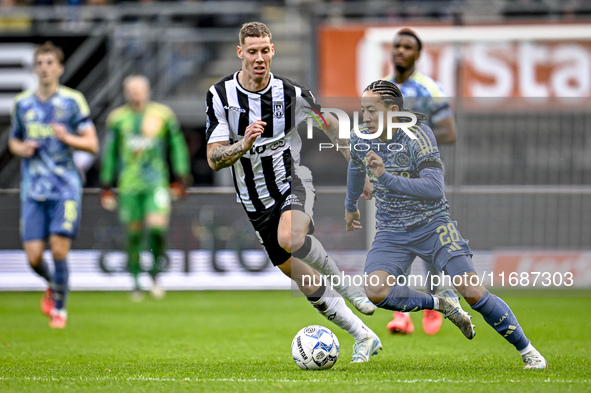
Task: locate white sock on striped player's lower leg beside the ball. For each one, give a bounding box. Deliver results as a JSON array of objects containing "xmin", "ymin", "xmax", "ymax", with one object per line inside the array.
[{"xmin": 310, "ymin": 287, "xmax": 371, "ymax": 341}]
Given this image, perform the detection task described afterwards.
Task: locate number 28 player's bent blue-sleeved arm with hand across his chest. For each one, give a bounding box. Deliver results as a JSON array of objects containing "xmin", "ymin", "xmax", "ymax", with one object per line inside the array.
[{"xmin": 366, "ymin": 151, "xmax": 445, "ymax": 200}]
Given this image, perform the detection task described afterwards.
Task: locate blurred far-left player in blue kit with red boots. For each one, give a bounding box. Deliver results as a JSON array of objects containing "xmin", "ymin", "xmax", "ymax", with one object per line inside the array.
[{"xmin": 8, "ymin": 42, "xmax": 98, "ymax": 328}]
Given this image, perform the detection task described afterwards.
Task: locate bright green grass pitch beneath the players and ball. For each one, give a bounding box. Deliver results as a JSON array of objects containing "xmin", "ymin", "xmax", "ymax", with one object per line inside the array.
[{"xmin": 0, "ymin": 291, "xmax": 591, "ymax": 393}]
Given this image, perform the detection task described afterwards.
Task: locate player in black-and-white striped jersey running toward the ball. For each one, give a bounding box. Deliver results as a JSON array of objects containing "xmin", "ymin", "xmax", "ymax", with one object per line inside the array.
[{"xmin": 206, "ymin": 22, "xmax": 381, "ymax": 362}]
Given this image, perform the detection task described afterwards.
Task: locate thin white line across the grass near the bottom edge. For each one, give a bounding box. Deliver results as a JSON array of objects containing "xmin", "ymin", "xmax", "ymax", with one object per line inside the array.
[{"xmin": 0, "ymin": 377, "xmax": 591, "ymax": 385}]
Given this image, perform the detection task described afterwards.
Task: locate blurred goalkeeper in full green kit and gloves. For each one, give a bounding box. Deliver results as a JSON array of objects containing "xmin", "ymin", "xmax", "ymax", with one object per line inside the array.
[{"xmin": 100, "ymin": 75, "xmax": 190, "ymax": 300}]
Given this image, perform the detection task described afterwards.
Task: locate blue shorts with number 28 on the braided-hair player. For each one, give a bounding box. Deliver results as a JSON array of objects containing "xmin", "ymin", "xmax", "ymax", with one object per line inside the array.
[{"xmin": 365, "ymin": 215, "xmax": 472, "ymax": 276}]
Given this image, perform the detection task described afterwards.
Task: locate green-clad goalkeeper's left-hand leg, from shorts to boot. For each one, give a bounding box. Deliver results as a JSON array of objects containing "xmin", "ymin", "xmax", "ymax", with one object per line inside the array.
[{"xmin": 119, "ymin": 194, "xmax": 144, "ymax": 301}]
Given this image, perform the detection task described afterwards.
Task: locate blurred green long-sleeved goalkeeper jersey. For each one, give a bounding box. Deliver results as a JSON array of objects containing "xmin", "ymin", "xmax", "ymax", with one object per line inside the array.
[{"xmin": 100, "ymin": 102, "xmax": 189, "ymax": 194}]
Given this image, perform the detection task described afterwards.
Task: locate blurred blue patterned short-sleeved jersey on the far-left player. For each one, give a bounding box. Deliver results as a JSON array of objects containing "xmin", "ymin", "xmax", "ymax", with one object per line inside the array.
[{"xmin": 10, "ymin": 86, "xmax": 92, "ymax": 201}]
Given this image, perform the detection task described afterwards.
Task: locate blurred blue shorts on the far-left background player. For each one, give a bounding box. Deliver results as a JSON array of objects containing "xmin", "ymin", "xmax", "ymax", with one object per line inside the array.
[{"xmin": 21, "ymin": 199, "xmax": 80, "ymax": 242}]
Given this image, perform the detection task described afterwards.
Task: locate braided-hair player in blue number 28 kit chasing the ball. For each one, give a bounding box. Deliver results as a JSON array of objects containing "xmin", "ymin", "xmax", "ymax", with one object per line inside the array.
[{"xmin": 345, "ymin": 80, "xmax": 547, "ymax": 369}]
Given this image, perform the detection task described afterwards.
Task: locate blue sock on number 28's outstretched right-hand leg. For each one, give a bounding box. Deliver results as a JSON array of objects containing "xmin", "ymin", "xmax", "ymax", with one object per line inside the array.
[{"xmin": 472, "ymin": 291, "xmax": 530, "ymax": 351}]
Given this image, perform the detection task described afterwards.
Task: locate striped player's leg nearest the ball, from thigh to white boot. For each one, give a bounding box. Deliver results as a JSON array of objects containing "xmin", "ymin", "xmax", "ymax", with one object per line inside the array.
[{"xmin": 278, "ymin": 257, "xmax": 382, "ymax": 363}]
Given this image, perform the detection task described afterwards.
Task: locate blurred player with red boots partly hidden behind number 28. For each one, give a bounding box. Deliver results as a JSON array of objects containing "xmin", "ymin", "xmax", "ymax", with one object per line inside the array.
[{"xmin": 384, "ymin": 29, "xmax": 456, "ymax": 334}]
